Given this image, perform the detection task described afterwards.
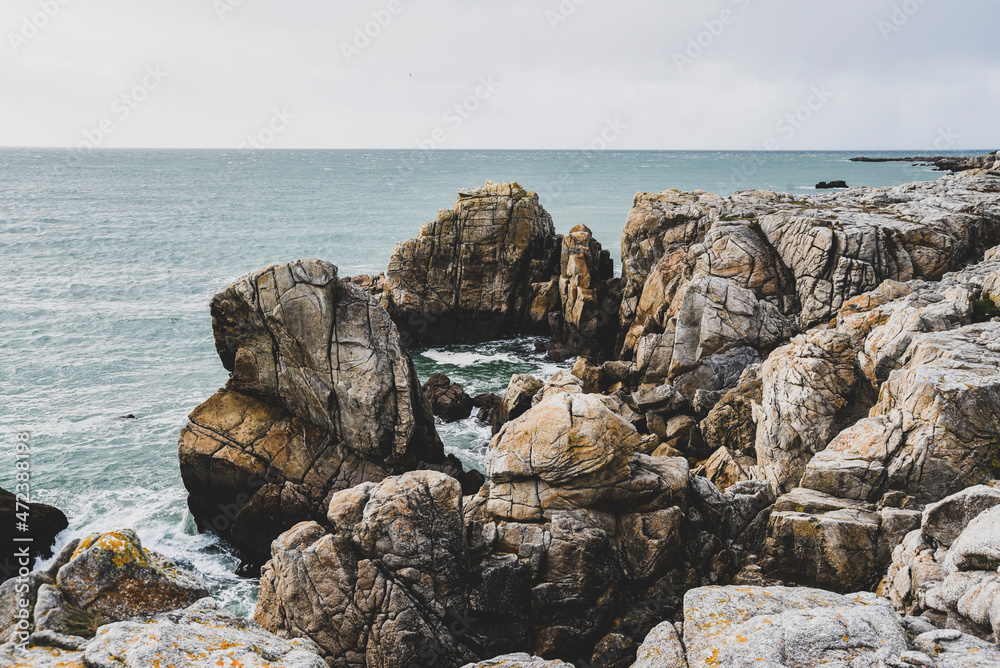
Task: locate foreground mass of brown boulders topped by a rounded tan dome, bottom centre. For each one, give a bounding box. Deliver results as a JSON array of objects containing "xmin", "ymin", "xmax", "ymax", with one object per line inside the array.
[{"xmin": 255, "ymin": 383, "xmax": 773, "ymax": 668}]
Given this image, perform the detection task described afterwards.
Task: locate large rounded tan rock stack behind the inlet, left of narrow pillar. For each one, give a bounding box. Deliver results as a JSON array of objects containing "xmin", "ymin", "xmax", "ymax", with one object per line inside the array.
[{"xmin": 383, "ymin": 181, "xmax": 559, "ymax": 345}]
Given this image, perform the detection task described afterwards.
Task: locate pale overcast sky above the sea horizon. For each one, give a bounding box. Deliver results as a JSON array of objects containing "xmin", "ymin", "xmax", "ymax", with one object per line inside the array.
[{"xmin": 0, "ymin": 0, "xmax": 1000, "ymax": 152}]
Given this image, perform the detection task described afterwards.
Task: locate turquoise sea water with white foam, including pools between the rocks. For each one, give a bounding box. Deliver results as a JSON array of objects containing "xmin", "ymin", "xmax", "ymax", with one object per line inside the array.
[{"xmin": 0, "ymin": 149, "xmax": 972, "ymax": 613}]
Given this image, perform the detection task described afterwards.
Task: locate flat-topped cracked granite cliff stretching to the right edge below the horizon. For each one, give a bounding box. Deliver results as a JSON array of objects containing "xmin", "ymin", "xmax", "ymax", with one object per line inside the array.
[{"xmin": 619, "ymin": 171, "xmax": 1000, "ymax": 394}]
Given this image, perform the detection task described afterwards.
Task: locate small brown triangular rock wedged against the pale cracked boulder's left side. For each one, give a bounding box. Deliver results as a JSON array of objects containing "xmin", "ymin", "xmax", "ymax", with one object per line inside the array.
[{"xmin": 701, "ymin": 365, "xmax": 763, "ymax": 456}]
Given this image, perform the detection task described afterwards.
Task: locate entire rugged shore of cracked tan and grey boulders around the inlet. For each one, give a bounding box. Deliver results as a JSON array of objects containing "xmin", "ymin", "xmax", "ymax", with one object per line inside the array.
[{"xmin": 0, "ymin": 159, "xmax": 1000, "ymax": 668}]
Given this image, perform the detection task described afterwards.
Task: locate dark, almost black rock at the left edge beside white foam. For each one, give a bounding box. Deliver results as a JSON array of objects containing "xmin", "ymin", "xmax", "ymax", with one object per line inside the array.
[{"xmin": 0, "ymin": 489, "xmax": 69, "ymax": 580}]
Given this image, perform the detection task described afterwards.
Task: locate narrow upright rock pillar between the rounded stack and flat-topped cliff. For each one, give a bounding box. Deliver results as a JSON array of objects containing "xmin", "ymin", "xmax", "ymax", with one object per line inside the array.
[{"xmin": 559, "ymin": 224, "xmax": 620, "ymax": 360}]
